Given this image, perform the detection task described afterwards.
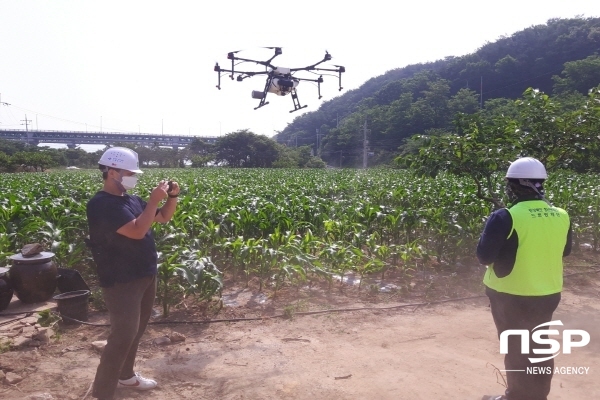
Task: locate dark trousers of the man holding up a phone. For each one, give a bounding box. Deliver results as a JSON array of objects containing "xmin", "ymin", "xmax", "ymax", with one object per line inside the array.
[{"xmin": 92, "ymin": 275, "xmax": 156, "ymax": 400}]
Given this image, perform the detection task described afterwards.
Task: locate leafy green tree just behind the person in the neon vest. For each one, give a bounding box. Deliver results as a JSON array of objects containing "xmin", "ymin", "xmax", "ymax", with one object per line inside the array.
[{"xmin": 396, "ymin": 87, "xmax": 600, "ymax": 207}]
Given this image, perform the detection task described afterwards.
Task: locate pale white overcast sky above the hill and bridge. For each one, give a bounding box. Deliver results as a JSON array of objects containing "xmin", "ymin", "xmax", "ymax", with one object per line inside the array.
[{"xmin": 0, "ymin": 0, "xmax": 600, "ymax": 152}]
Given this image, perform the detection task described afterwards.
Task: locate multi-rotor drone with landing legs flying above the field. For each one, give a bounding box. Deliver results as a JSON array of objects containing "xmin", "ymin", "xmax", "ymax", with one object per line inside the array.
[{"xmin": 215, "ymin": 47, "xmax": 346, "ymax": 113}]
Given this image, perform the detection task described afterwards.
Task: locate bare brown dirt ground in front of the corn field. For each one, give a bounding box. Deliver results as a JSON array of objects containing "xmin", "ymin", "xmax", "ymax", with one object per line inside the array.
[{"xmin": 0, "ymin": 260, "xmax": 600, "ymax": 400}]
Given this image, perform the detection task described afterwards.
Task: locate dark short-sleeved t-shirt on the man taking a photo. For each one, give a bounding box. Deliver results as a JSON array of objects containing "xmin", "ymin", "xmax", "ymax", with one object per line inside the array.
[{"xmin": 87, "ymin": 191, "xmax": 157, "ymax": 287}]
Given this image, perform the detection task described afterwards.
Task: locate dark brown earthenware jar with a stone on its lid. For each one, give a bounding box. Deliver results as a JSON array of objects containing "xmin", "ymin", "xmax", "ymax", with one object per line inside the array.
[{"xmin": 8, "ymin": 252, "xmax": 57, "ymax": 304}]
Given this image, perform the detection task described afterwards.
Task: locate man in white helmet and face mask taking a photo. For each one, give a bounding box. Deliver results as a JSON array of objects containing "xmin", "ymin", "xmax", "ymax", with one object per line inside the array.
[{"xmin": 87, "ymin": 147, "xmax": 179, "ymax": 400}]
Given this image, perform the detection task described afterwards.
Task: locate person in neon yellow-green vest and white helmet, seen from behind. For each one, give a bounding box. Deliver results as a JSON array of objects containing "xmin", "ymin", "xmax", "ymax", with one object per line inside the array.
[{"xmin": 477, "ymin": 157, "xmax": 571, "ymax": 400}]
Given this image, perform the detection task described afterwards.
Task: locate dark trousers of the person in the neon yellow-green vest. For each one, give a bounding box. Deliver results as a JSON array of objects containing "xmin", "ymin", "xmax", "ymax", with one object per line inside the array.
[{"xmin": 486, "ymin": 288, "xmax": 560, "ymax": 400}]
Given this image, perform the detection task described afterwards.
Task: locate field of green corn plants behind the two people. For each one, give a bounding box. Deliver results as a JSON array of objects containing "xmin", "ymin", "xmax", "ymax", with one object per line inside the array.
[{"xmin": 0, "ymin": 168, "xmax": 600, "ymax": 308}]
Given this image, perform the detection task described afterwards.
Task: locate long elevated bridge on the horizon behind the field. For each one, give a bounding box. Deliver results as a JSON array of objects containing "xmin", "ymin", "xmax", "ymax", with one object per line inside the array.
[{"xmin": 0, "ymin": 129, "xmax": 218, "ymax": 149}]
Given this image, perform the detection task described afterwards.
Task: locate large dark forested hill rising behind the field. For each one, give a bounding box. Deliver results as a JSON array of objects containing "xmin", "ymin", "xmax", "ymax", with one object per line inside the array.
[{"xmin": 275, "ymin": 18, "xmax": 600, "ymax": 166}]
